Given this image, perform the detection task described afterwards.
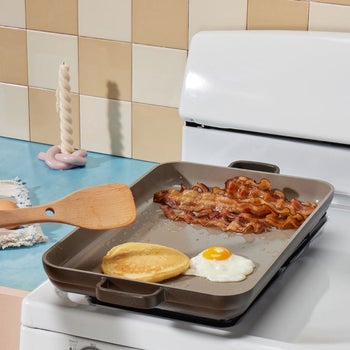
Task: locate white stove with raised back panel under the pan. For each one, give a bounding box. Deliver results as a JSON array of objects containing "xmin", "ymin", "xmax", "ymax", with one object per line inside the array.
[{"xmin": 20, "ymin": 31, "xmax": 350, "ymax": 350}]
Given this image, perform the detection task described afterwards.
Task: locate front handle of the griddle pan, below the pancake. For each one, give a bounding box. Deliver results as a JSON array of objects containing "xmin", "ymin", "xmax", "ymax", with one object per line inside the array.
[{"xmin": 96, "ymin": 278, "xmax": 165, "ymax": 309}]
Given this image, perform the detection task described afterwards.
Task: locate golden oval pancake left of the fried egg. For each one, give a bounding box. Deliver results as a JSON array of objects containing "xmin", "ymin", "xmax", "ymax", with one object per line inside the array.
[{"xmin": 101, "ymin": 242, "xmax": 190, "ymax": 282}]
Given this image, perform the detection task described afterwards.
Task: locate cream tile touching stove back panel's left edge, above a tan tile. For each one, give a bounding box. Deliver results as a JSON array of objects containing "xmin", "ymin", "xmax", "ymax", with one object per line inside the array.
[{"xmin": 132, "ymin": 44, "xmax": 187, "ymax": 108}]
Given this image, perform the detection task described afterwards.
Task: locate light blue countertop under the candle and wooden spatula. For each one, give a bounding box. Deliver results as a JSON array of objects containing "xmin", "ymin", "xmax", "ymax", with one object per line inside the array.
[{"xmin": 0, "ymin": 137, "xmax": 156, "ymax": 291}]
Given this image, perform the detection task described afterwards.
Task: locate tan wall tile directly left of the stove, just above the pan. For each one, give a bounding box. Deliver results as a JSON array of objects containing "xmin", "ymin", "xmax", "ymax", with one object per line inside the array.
[{"xmin": 132, "ymin": 103, "xmax": 183, "ymax": 162}]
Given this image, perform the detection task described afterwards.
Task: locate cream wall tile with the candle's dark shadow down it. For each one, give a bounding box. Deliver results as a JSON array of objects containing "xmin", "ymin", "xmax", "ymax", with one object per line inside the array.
[{"xmin": 80, "ymin": 95, "xmax": 131, "ymax": 157}]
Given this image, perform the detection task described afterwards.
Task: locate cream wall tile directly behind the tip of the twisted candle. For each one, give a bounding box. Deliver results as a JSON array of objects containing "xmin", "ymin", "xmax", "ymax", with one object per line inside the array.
[{"xmin": 27, "ymin": 30, "xmax": 78, "ymax": 92}]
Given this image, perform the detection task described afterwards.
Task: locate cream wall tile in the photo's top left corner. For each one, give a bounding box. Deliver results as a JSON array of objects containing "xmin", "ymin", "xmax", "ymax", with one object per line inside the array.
[{"xmin": 0, "ymin": 0, "xmax": 26, "ymax": 28}]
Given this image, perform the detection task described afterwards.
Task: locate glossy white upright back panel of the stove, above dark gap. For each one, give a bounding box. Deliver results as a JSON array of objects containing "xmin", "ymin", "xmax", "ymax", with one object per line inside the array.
[{"xmin": 180, "ymin": 31, "xmax": 350, "ymax": 144}]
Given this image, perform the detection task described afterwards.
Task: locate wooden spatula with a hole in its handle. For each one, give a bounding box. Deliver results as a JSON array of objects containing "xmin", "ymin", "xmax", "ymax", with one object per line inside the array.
[{"xmin": 0, "ymin": 184, "xmax": 136, "ymax": 230}]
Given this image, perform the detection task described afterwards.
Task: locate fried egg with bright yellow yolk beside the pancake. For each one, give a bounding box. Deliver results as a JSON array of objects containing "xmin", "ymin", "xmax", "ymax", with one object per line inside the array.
[{"xmin": 184, "ymin": 246, "xmax": 255, "ymax": 282}]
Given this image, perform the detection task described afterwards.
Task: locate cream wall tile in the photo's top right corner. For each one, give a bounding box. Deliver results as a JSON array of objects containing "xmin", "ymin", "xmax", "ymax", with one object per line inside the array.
[{"xmin": 309, "ymin": 2, "xmax": 350, "ymax": 32}]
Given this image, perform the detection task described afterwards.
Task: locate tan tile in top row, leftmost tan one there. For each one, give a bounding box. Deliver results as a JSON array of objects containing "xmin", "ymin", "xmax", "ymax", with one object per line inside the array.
[{"xmin": 26, "ymin": 0, "xmax": 78, "ymax": 34}]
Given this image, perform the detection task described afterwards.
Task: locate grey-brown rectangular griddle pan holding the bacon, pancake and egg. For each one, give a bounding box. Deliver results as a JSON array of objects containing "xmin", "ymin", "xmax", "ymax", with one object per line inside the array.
[{"xmin": 43, "ymin": 162, "xmax": 334, "ymax": 324}]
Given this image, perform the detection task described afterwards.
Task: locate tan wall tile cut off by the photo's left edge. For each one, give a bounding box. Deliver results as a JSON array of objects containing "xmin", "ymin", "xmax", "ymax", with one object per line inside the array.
[{"xmin": 0, "ymin": 27, "xmax": 28, "ymax": 85}]
